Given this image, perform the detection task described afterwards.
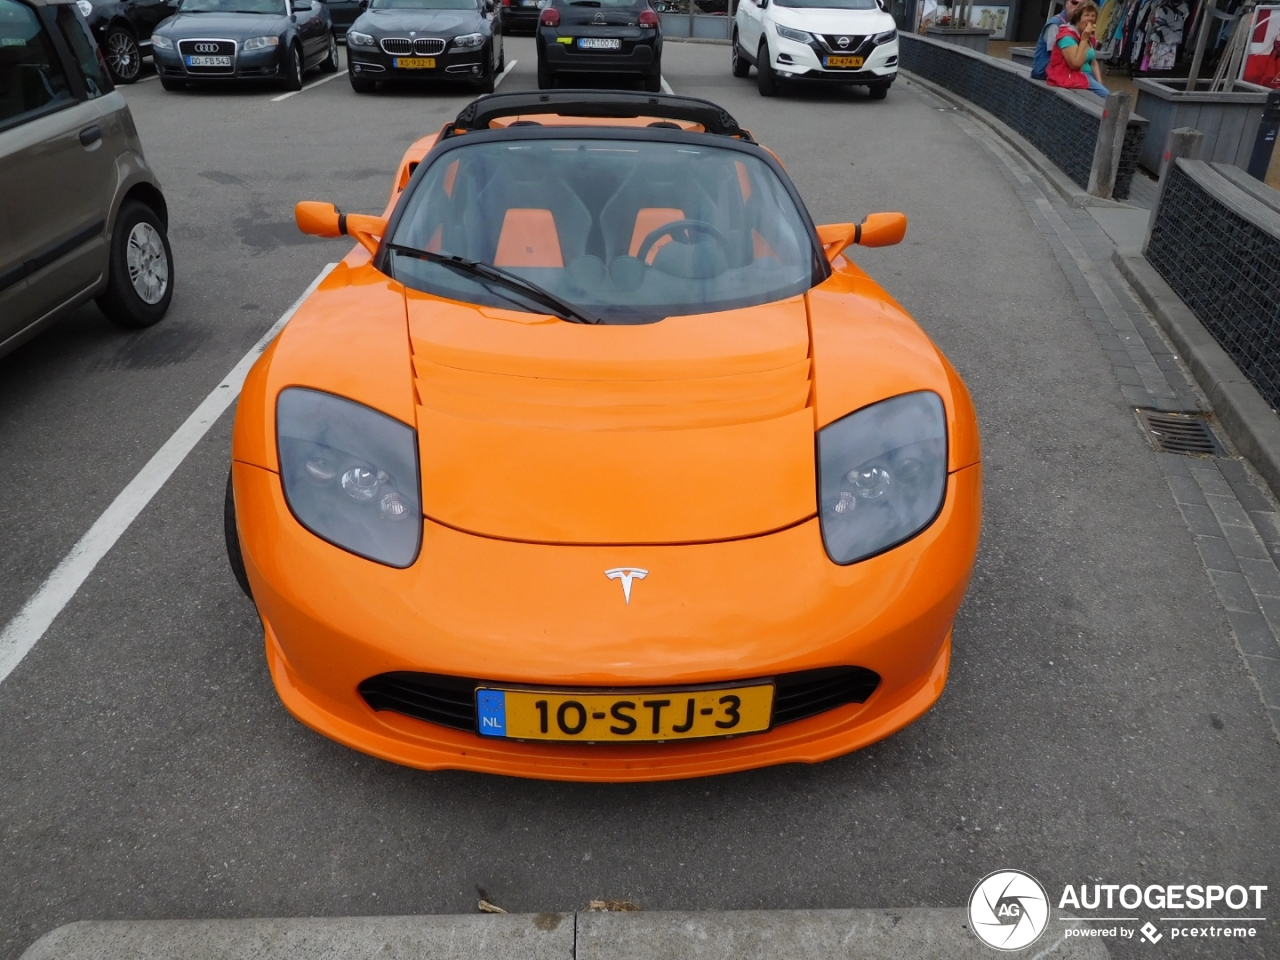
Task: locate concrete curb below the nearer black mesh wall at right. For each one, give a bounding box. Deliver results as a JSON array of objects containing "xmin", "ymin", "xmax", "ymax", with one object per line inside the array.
[{"xmin": 1111, "ymin": 250, "xmax": 1280, "ymax": 497}]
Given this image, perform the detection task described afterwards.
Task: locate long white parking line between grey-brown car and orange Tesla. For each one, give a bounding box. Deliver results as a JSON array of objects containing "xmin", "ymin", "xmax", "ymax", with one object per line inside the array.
[{"xmin": 0, "ymin": 264, "xmax": 337, "ymax": 682}]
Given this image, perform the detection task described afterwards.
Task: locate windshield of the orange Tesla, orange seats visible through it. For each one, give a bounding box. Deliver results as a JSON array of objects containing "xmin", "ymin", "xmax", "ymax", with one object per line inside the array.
[{"xmin": 388, "ymin": 138, "xmax": 817, "ymax": 324}]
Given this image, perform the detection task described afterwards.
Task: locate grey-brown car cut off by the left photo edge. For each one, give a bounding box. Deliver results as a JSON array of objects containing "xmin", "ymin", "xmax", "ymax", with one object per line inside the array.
[{"xmin": 0, "ymin": 0, "xmax": 173, "ymax": 355}]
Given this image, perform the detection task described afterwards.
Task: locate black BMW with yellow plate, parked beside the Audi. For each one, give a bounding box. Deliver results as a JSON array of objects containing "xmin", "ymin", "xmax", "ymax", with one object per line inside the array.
[{"xmin": 347, "ymin": 0, "xmax": 507, "ymax": 93}]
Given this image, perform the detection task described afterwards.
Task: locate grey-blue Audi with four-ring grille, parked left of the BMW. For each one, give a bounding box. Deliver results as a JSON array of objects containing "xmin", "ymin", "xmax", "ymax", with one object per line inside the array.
[{"xmin": 151, "ymin": 0, "xmax": 338, "ymax": 90}]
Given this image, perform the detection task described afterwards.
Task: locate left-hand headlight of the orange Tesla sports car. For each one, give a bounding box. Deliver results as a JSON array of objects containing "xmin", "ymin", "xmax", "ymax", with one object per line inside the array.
[{"xmin": 275, "ymin": 387, "xmax": 422, "ymax": 567}]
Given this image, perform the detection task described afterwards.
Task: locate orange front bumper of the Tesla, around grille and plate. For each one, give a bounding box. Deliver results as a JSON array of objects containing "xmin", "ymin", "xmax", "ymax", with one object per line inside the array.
[{"xmin": 233, "ymin": 462, "xmax": 980, "ymax": 781}]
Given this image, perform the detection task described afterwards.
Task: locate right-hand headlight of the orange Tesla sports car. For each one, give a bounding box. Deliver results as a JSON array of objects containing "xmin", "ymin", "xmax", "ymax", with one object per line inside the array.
[{"xmin": 818, "ymin": 390, "xmax": 947, "ymax": 563}]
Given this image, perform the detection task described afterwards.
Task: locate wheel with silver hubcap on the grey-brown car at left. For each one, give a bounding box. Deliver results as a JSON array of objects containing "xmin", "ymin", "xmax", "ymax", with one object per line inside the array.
[{"xmin": 97, "ymin": 200, "xmax": 173, "ymax": 330}]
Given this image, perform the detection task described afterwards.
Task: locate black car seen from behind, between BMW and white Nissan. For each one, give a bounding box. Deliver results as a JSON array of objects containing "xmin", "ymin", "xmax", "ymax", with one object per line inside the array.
[{"xmin": 538, "ymin": 0, "xmax": 662, "ymax": 93}]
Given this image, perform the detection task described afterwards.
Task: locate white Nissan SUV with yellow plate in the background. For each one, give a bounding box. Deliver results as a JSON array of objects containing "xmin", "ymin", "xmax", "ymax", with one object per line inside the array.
[{"xmin": 732, "ymin": 0, "xmax": 897, "ymax": 100}]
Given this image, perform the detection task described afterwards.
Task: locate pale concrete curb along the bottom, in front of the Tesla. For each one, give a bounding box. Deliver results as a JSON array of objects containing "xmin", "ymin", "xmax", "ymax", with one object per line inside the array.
[{"xmin": 22, "ymin": 908, "xmax": 1108, "ymax": 960}]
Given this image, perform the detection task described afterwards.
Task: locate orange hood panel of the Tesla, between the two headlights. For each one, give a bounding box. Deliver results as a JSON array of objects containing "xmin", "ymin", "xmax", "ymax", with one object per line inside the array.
[{"xmin": 407, "ymin": 291, "xmax": 817, "ymax": 544}]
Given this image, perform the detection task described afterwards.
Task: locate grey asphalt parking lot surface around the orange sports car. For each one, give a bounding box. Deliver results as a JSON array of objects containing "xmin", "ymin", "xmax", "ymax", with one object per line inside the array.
[{"xmin": 0, "ymin": 38, "xmax": 1280, "ymax": 957}]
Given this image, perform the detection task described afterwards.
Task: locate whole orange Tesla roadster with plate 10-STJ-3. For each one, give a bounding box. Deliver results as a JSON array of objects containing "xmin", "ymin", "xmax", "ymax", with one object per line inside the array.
[{"xmin": 227, "ymin": 91, "xmax": 982, "ymax": 781}]
